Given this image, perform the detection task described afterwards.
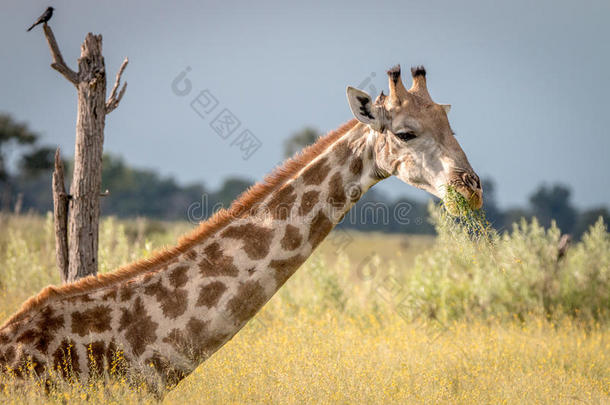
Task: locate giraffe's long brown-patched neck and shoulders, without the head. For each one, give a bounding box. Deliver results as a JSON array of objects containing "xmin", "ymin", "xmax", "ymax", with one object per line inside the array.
[{"xmin": 0, "ymin": 123, "xmax": 379, "ymax": 382}]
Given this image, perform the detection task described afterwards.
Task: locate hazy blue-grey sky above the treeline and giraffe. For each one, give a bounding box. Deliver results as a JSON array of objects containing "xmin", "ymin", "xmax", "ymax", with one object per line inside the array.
[{"xmin": 0, "ymin": 0, "xmax": 610, "ymax": 207}]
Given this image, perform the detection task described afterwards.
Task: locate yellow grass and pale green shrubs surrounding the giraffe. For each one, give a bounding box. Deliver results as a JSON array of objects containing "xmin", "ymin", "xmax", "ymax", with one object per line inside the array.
[{"xmin": 0, "ymin": 200, "xmax": 610, "ymax": 404}]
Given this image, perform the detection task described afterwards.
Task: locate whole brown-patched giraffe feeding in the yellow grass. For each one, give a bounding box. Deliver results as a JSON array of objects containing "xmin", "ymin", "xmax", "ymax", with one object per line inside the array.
[{"xmin": 0, "ymin": 66, "xmax": 482, "ymax": 386}]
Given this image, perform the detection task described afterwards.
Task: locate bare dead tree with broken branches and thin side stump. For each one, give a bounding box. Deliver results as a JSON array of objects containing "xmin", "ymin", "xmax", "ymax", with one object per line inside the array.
[{"xmin": 43, "ymin": 23, "xmax": 128, "ymax": 282}]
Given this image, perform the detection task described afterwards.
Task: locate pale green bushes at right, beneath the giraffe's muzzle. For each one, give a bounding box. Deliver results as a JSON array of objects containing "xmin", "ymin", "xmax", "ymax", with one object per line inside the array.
[{"xmin": 405, "ymin": 197, "xmax": 610, "ymax": 321}]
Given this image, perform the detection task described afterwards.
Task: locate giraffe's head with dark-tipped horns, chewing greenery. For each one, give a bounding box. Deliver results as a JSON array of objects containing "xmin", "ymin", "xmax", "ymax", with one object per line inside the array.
[{"xmin": 347, "ymin": 66, "xmax": 483, "ymax": 209}]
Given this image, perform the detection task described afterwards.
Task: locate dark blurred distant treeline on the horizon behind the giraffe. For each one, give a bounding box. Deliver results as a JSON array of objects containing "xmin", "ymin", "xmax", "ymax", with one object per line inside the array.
[{"xmin": 0, "ymin": 114, "xmax": 610, "ymax": 238}]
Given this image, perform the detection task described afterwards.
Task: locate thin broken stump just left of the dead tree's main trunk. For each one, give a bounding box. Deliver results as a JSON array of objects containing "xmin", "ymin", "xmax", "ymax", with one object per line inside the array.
[{"xmin": 53, "ymin": 148, "xmax": 68, "ymax": 283}]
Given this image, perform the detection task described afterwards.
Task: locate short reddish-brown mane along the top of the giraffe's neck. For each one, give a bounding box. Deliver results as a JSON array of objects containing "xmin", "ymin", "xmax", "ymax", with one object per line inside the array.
[{"xmin": 0, "ymin": 119, "xmax": 358, "ymax": 329}]
